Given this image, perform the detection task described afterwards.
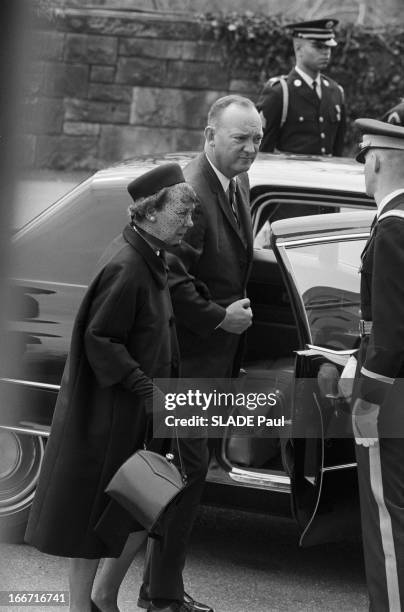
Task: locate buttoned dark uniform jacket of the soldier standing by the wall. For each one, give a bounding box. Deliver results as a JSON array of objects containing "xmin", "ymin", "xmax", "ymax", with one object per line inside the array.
[{"xmin": 257, "ymin": 69, "xmax": 345, "ymax": 156}]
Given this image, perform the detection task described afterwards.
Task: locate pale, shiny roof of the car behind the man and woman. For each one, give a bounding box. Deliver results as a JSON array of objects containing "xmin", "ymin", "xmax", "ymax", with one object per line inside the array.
[{"xmin": 93, "ymin": 151, "xmax": 365, "ymax": 194}]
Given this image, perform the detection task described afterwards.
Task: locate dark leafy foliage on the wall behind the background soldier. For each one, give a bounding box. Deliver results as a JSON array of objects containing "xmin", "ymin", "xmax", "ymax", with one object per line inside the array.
[{"xmin": 200, "ymin": 12, "xmax": 404, "ymax": 153}]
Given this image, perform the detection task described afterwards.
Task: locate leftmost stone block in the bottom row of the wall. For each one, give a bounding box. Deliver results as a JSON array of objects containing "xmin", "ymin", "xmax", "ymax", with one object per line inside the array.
[{"xmin": 35, "ymin": 136, "xmax": 100, "ymax": 170}]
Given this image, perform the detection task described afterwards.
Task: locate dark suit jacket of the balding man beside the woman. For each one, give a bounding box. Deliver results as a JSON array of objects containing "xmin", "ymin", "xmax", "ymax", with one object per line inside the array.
[{"xmin": 169, "ymin": 153, "xmax": 253, "ymax": 377}]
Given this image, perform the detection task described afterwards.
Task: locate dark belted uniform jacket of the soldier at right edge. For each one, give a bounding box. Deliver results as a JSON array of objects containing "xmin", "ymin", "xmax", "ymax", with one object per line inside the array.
[{"xmin": 355, "ymin": 189, "xmax": 404, "ymax": 420}]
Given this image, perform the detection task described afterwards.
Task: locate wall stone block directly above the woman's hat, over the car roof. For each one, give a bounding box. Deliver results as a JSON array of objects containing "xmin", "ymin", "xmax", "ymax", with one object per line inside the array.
[{"xmin": 99, "ymin": 125, "xmax": 176, "ymax": 163}]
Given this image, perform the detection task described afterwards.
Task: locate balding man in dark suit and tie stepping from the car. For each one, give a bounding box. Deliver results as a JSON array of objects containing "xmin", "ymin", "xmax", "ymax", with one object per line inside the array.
[{"xmin": 91, "ymin": 95, "xmax": 262, "ymax": 612}]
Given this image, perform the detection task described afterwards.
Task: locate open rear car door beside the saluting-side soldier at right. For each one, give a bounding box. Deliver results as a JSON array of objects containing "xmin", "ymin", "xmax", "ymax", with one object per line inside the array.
[{"xmin": 271, "ymin": 212, "xmax": 374, "ymax": 546}]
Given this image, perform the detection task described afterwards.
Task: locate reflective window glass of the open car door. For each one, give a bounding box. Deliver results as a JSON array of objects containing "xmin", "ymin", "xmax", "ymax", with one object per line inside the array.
[{"xmin": 285, "ymin": 239, "xmax": 365, "ymax": 350}]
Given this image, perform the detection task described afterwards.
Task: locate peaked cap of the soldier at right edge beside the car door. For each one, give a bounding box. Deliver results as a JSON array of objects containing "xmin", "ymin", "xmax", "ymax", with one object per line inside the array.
[{"xmin": 355, "ymin": 119, "xmax": 404, "ymax": 164}]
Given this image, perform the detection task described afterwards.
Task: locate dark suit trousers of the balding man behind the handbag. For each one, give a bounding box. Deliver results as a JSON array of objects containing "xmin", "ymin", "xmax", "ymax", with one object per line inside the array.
[{"xmin": 141, "ymin": 438, "xmax": 209, "ymax": 601}]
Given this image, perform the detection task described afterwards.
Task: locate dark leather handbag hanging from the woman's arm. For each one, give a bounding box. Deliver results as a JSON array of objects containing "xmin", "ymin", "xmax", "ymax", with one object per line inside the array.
[{"xmin": 105, "ymin": 450, "xmax": 186, "ymax": 537}]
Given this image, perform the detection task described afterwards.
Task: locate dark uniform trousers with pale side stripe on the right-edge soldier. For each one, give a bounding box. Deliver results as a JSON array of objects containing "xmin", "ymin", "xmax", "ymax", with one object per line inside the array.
[{"xmin": 355, "ymin": 438, "xmax": 404, "ymax": 612}]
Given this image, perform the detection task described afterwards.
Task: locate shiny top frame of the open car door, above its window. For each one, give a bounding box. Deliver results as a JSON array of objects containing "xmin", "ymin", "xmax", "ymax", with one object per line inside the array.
[{"xmin": 271, "ymin": 210, "xmax": 375, "ymax": 241}]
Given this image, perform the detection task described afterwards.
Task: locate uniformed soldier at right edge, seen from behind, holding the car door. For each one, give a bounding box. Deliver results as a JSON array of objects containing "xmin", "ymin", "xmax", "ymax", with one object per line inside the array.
[{"xmin": 352, "ymin": 119, "xmax": 404, "ymax": 612}]
